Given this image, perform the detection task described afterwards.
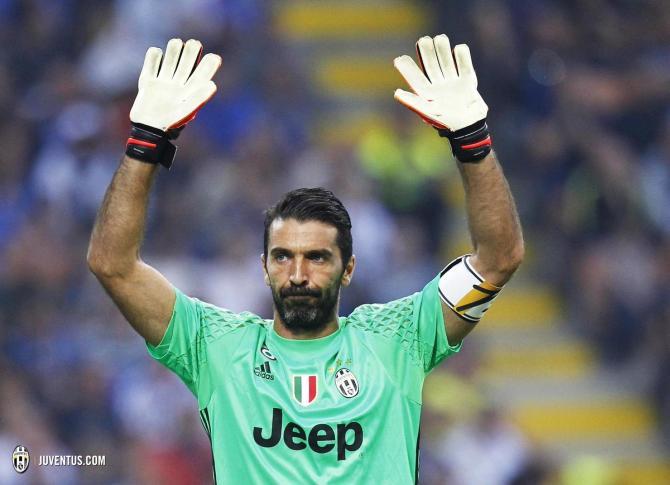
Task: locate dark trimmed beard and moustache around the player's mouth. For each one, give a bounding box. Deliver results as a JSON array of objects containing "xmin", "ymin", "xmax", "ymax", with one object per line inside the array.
[{"xmin": 272, "ymin": 283, "xmax": 340, "ymax": 332}]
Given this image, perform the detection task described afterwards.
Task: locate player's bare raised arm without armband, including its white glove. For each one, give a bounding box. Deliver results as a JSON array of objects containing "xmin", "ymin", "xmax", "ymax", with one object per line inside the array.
[{"xmin": 87, "ymin": 39, "xmax": 221, "ymax": 345}]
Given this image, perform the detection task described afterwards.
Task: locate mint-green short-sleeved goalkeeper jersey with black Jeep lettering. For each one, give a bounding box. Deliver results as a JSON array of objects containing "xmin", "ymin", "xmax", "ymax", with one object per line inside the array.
[{"xmin": 148, "ymin": 278, "xmax": 460, "ymax": 484}]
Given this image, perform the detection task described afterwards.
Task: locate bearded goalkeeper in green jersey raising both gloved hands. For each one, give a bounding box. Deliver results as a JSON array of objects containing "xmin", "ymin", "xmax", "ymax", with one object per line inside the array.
[{"xmin": 88, "ymin": 35, "xmax": 523, "ymax": 484}]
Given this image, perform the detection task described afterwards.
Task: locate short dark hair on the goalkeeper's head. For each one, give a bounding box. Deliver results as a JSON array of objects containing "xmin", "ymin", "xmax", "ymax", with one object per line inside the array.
[{"xmin": 263, "ymin": 187, "xmax": 353, "ymax": 267}]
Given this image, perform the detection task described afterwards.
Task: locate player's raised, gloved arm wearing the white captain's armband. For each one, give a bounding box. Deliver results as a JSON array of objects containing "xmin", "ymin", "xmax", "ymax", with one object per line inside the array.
[{"xmin": 394, "ymin": 35, "xmax": 524, "ymax": 344}]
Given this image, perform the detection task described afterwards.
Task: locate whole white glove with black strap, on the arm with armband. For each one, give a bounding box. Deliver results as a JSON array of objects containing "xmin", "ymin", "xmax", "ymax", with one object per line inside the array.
[{"xmin": 393, "ymin": 34, "xmax": 491, "ymax": 162}]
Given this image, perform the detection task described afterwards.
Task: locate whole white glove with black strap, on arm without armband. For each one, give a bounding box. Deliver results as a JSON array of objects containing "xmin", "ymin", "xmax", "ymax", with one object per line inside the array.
[{"xmin": 126, "ymin": 39, "xmax": 221, "ymax": 168}]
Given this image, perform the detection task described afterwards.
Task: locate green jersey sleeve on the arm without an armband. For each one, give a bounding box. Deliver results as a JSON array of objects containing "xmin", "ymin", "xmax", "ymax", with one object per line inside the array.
[{"xmin": 147, "ymin": 288, "xmax": 203, "ymax": 394}]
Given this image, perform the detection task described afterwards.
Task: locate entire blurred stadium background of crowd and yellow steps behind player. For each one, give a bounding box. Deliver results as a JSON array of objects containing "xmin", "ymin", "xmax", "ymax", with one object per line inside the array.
[{"xmin": 0, "ymin": 0, "xmax": 670, "ymax": 485}]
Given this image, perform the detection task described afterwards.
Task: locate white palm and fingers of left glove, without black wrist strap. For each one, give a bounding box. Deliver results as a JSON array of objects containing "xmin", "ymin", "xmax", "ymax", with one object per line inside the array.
[{"xmin": 130, "ymin": 39, "xmax": 221, "ymax": 131}]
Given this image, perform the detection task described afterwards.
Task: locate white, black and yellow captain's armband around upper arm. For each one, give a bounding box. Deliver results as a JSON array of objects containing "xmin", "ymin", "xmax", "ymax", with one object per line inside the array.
[{"xmin": 438, "ymin": 254, "xmax": 502, "ymax": 323}]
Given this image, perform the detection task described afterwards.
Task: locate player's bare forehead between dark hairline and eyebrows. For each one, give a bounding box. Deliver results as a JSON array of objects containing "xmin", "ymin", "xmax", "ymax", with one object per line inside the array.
[{"xmin": 268, "ymin": 218, "xmax": 338, "ymax": 252}]
